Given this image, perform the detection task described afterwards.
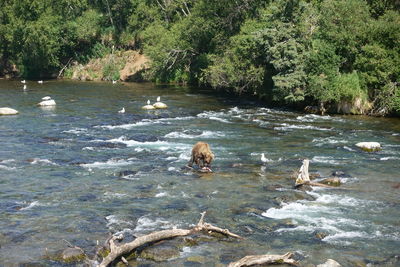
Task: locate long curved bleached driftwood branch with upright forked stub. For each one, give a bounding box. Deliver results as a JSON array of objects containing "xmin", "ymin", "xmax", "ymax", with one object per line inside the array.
[{"xmin": 98, "ymin": 212, "xmax": 242, "ymax": 267}]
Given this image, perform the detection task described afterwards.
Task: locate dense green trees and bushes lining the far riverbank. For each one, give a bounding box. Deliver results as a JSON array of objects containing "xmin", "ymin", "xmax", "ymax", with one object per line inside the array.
[{"xmin": 0, "ymin": 0, "xmax": 400, "ymax": 114}]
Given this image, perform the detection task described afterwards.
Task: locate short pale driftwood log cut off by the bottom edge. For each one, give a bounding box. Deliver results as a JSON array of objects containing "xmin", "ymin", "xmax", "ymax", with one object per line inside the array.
[{"xmin": 228, "ymin": 252, "xmax": 298, "ymax": 267}]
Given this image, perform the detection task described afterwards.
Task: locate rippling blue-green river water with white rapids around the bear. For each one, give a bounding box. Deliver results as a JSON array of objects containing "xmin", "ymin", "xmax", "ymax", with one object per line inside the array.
[{"xmin": 0, "ymin": 80, "xmax": 400, "ymax": 266}]
